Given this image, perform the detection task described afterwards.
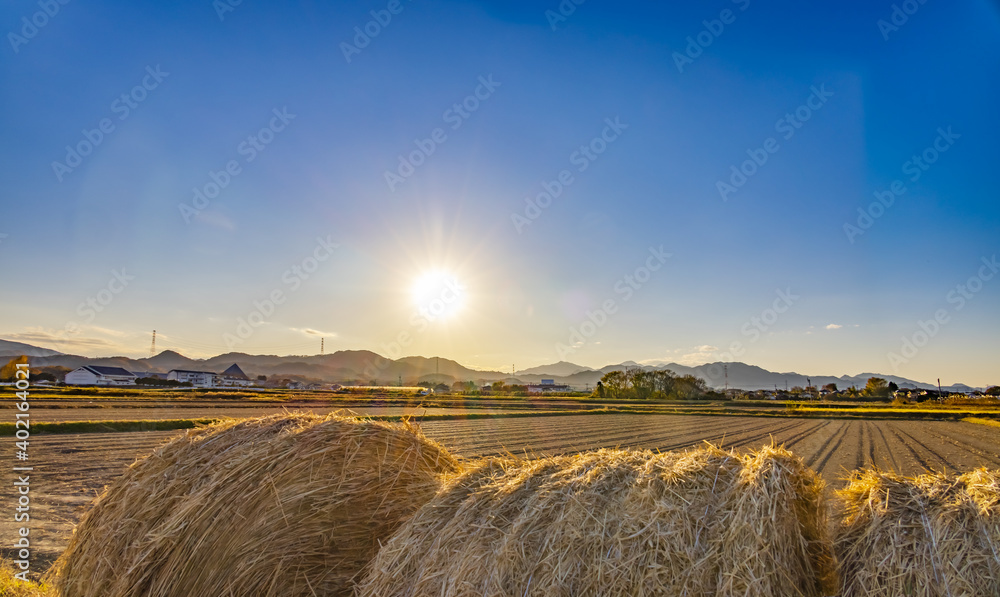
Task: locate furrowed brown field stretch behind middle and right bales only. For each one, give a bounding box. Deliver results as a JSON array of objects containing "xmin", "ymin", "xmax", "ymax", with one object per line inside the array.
[{"xmin": 421, "ymin": 415, "xmax": 1000, "ymax": 472}]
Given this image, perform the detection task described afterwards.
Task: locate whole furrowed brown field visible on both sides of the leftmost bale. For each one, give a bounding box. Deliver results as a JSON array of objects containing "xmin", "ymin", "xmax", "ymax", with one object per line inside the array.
[{"xmin": 0, "ymin": 415, "xmax": 1000, "ymax": 569}]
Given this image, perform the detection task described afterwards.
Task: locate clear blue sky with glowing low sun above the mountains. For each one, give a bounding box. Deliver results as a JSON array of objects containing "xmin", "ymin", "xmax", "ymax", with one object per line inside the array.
[{"xmin": 0, "ymin": 0, "xmax": 1000, "ymax": 385}]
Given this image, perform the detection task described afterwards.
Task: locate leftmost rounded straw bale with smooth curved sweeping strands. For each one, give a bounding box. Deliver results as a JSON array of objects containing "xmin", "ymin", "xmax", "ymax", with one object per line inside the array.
[{"xmin": 44, "ymin": 414, "xmax": 457, "ymax": 597}]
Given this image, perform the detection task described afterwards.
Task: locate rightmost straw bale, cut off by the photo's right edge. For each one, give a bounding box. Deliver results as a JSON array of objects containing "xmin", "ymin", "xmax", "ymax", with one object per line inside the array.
[{"xmin": 836, "ymin": 469, "xmax": 1000, "ymax": 597}]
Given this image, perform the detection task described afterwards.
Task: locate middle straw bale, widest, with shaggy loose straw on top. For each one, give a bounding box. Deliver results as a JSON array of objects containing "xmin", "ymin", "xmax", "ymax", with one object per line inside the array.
[{"xmin": 359, "ymin": 446, "xmax": 834, "ymax": 597}]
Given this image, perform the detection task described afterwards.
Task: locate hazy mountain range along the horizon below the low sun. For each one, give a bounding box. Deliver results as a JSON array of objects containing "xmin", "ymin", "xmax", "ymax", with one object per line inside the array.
[{"xmin": 0, "ymin": 340, "xmax": 976, "ymax": 392}]
